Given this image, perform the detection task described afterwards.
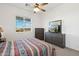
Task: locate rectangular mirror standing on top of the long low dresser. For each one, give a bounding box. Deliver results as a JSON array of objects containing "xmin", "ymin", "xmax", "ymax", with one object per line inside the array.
[{"xmin": 48, "ymin": 20, "xmax": 62, "ymax": 33}]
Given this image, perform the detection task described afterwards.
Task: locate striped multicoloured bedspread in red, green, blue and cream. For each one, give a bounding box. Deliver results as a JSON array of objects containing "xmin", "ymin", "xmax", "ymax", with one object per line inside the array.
[{"xmin": 0, "ymin": 38, "xmax": 55, "ymax": 56}]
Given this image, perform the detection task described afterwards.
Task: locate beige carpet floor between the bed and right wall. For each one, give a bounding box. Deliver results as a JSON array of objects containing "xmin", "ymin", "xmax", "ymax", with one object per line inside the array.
[{"xmin": 52, "ymin": 44, "xmax": 79, "ymax": 56}]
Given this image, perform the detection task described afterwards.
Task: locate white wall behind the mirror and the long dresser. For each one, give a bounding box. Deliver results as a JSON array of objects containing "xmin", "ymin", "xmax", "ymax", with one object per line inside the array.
[{"xmin": 43, "ymin": 3, "xmax": 79, "ymax": 51}]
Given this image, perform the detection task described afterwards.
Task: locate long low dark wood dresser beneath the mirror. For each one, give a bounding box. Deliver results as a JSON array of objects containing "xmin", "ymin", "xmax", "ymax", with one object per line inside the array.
[{"xmin": 45, "ymin": 32, "xmax": 65, "ymax": 48}]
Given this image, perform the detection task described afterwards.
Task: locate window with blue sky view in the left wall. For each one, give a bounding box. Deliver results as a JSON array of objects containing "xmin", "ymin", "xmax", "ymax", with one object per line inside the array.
[{"xmin": 16, "ymin": 16, "xmax": 31, "ymax": 32}]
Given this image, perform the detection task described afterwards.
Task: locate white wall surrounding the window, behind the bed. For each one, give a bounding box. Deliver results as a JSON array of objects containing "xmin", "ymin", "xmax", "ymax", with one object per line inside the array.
[{"xmin": 0, "ymin": 4, "xmax": 41, "ymax": 40}]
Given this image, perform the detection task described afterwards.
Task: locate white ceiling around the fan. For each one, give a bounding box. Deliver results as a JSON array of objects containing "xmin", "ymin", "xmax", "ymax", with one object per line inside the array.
[{"xmin": 5, "ymin": 3, "xmax": 62, "ymax": 11}]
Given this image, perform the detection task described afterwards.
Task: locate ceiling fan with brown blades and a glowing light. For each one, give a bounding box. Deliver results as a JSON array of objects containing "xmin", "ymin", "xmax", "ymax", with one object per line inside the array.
[{"xmin": 25, "ymin": 3, "xmax": 48, "ymax": 13}]
